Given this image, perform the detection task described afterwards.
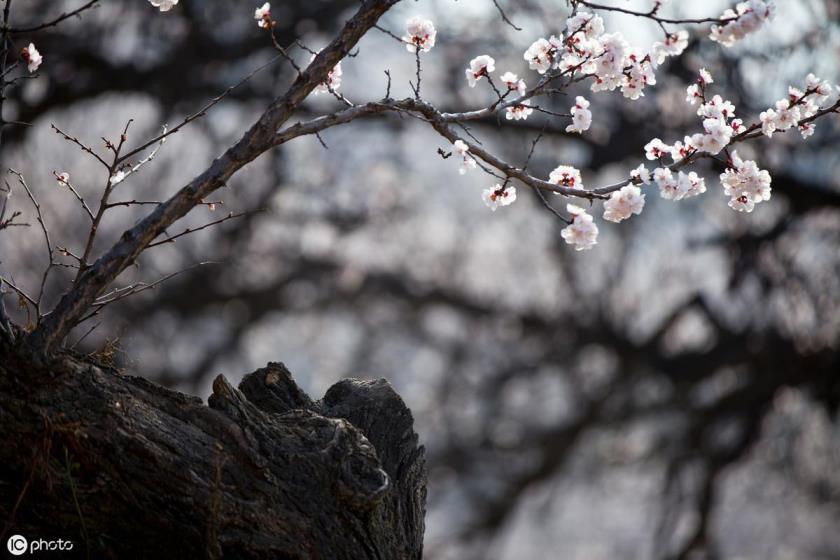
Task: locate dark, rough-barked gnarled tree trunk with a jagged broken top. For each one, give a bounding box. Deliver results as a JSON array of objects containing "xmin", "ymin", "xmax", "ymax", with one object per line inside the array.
[{"xmin": 0, "ymin": 337, "xmax": 426, "ymax": 559}]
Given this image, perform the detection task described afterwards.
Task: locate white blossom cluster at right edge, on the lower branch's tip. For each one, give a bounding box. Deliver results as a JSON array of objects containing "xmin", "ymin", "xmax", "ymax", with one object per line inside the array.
[{"xmin": 759, "ymin": 74, "xmax": 832, "ymax": 138}]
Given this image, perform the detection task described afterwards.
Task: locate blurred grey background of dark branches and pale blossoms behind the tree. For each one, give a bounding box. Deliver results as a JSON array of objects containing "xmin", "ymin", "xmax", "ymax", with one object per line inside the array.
[{"xmin": 0, "ymin": 0, "xmax": 840, "ymax": 560}]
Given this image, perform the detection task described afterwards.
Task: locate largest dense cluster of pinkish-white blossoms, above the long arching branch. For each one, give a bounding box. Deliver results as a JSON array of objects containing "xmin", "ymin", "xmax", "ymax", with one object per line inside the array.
[{"xmin": 523, "ymin": 12, "xmax": 688, "ymax": 99}]
